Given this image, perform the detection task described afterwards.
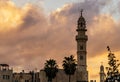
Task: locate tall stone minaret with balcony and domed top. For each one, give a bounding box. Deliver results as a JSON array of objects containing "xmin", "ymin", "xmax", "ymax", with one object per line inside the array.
[{"xmin": 76, "ymin": 10, "xmax": 88, "ymax": 82}]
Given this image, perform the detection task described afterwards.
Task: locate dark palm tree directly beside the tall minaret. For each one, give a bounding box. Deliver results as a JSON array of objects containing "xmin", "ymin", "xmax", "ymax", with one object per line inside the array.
[{"xmin": 62, "ymin": 55, "xmax": 77, "ymax": 82}]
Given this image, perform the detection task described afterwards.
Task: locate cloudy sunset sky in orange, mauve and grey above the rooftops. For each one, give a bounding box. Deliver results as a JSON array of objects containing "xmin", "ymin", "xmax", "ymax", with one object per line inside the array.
[{"xmin": 0, "ymin": 0, "xmax": 120, "ymax": 82}]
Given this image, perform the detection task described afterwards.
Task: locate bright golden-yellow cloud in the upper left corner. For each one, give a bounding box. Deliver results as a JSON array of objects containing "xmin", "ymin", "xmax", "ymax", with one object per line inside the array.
[{"xmin": 0, "ymin": 0, "xmax": 30, "ymax": 32}]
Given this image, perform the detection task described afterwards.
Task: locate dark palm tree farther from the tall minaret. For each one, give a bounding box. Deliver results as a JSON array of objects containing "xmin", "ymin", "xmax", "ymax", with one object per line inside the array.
[{"xmin": 44, "ymin": 59, "xmax": 58, "ymax": 82}]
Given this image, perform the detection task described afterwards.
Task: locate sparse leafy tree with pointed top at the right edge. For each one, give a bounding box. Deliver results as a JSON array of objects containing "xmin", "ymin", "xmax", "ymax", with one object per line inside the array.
[{"xmin": 106, "ymin": 46, "xmax": 120, "ymax": 82}]
